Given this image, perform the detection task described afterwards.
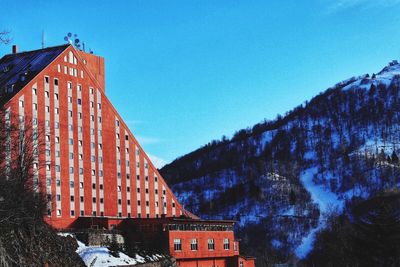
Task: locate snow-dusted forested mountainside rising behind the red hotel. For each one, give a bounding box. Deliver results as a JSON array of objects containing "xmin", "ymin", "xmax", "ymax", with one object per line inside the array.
[{"xmin": 161, "ymin": 61, "xmax": 400, "ymax": 266}]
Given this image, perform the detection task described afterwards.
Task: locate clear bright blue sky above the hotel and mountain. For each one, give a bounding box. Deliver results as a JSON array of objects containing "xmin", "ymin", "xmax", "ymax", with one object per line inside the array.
[{"xmin": 0, "ymin": 0, "xmax": 400, "ymax": 168}]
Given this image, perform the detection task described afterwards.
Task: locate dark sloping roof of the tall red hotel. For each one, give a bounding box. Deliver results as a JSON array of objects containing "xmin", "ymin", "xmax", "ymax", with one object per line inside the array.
[{"xmin": 0, "ymin": 45, "xmax": 69, "ymax": 104}]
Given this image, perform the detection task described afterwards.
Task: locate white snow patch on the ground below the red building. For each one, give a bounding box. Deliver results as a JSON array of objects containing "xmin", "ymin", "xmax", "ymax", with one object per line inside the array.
[{"xmin": 76, "ymin": 241, "xmax": 146, "ymax": 267}]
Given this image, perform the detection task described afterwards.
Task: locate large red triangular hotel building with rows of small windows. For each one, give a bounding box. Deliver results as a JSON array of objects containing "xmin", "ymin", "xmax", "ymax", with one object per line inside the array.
[{"xmin": 0, "ymin": 44, "xmax": 254, "ymax": 267}]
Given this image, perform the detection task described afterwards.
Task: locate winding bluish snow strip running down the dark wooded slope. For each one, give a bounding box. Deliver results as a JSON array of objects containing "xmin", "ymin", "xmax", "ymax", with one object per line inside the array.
[{"xmin": 295, "ymin": 167, "xmax": 343, "ymax": 258}]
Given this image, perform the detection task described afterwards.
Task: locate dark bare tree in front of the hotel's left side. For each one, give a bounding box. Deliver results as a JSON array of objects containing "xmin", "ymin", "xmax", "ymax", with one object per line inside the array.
[{"xmin": 0, "ymin": 108, "xmax": 84, "ymax": 267}]
